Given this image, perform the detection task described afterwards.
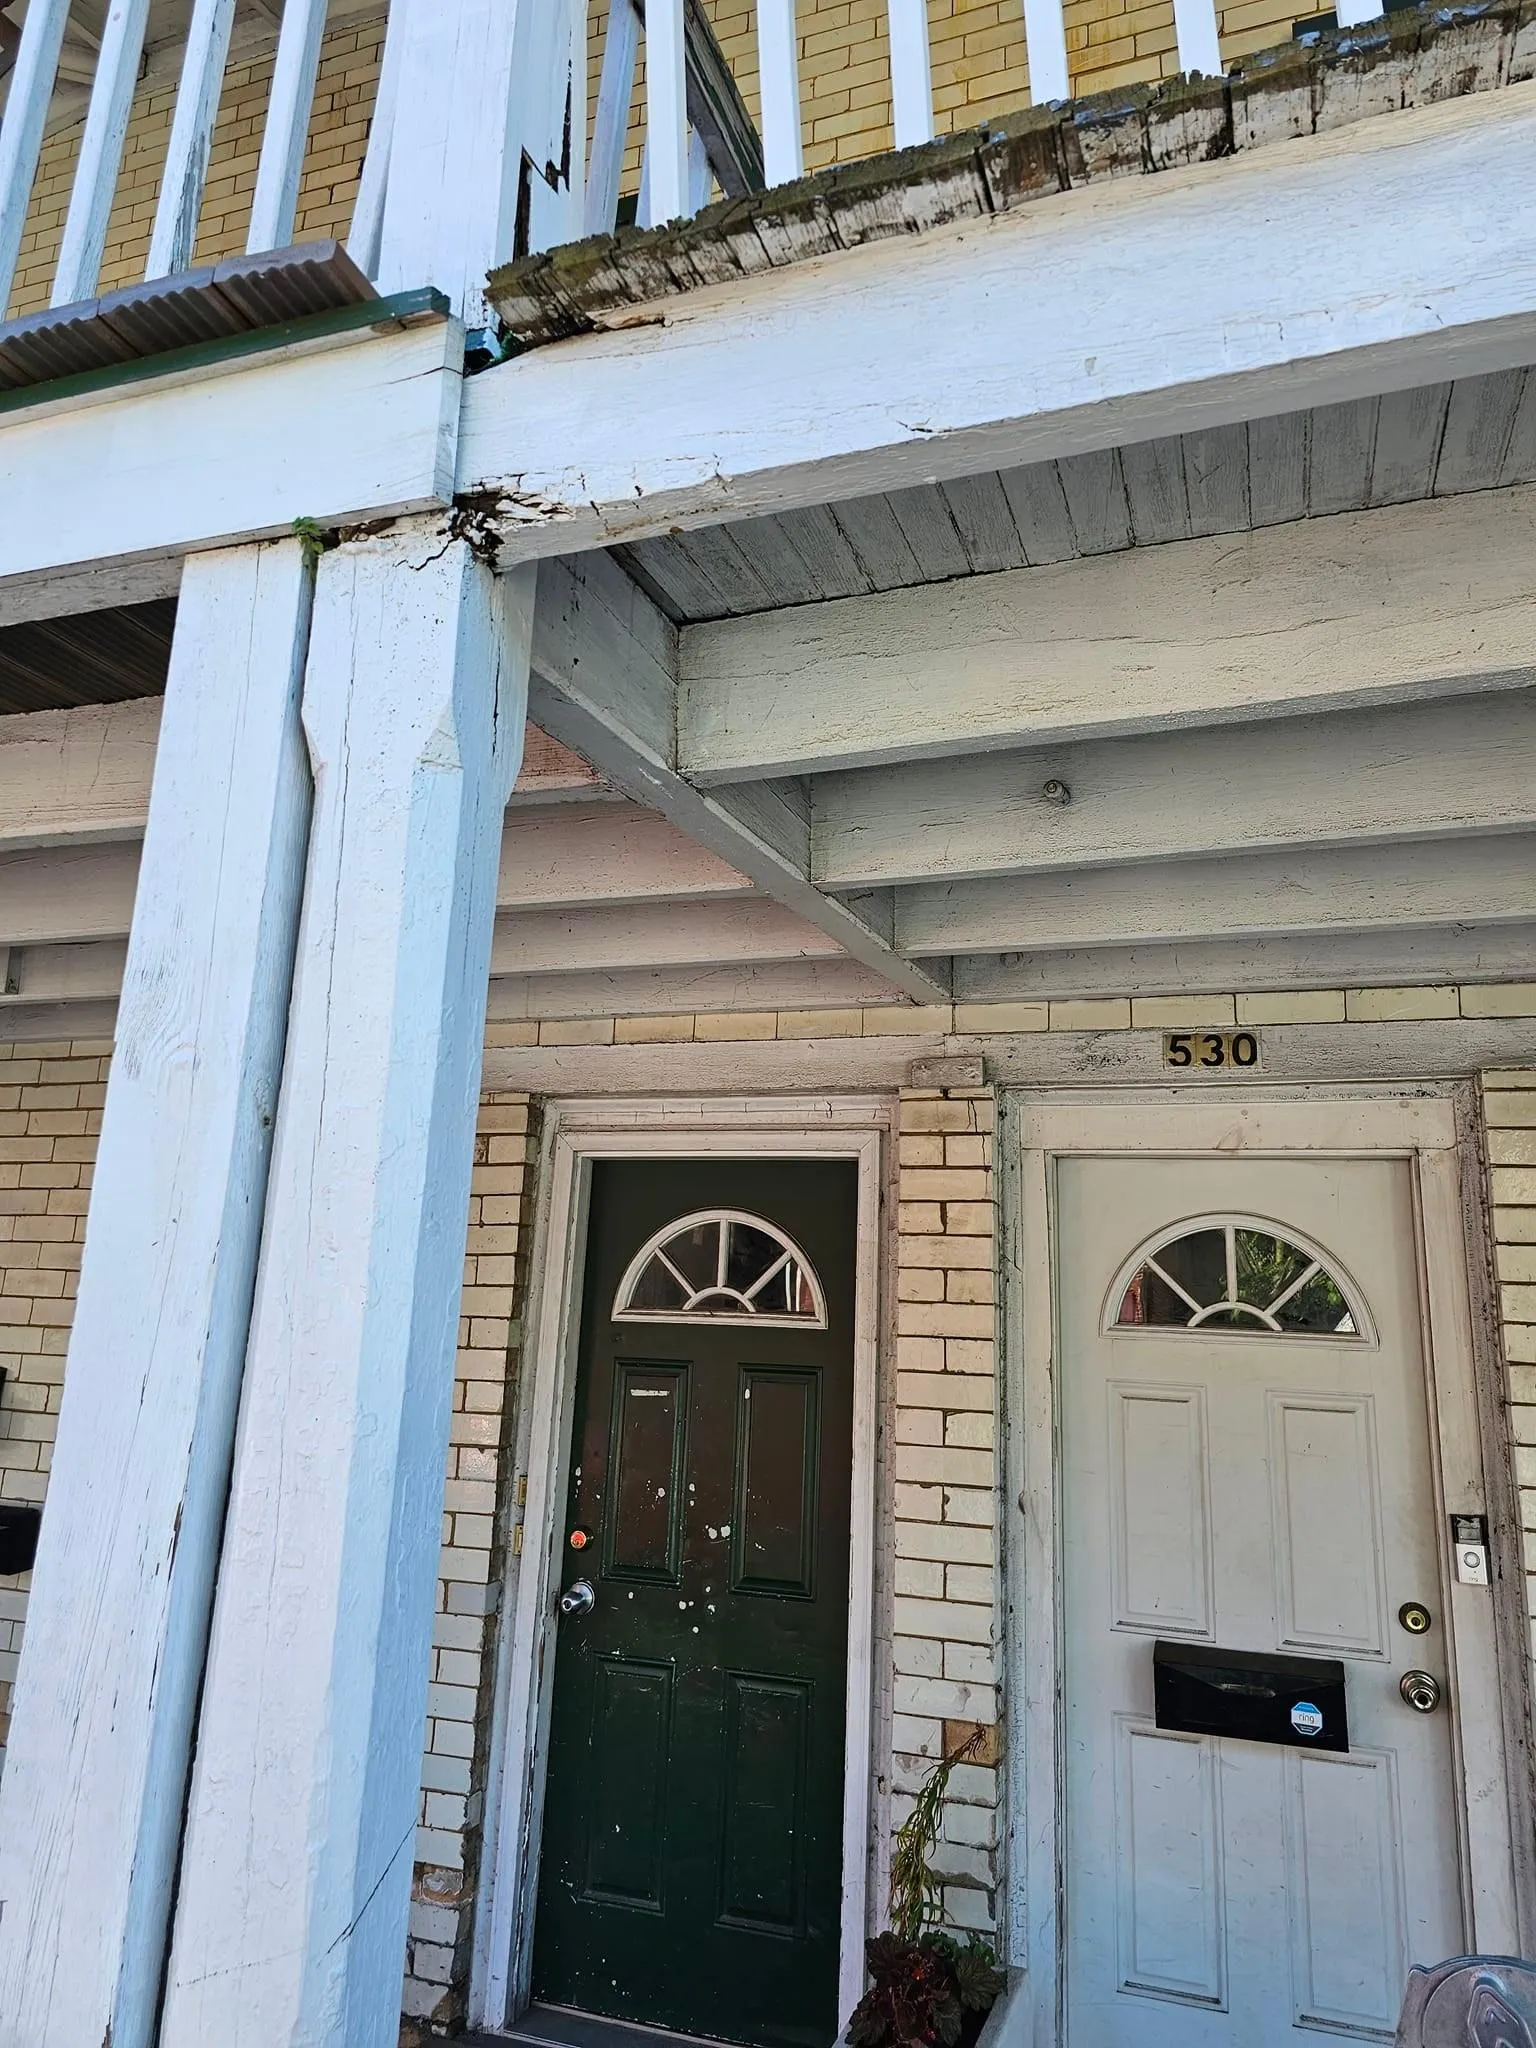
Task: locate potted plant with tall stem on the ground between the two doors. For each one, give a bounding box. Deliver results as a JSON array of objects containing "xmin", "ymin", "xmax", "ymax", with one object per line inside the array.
[{"xmin": 848, "ymin": 1729, "xmax": 1008, "ymax": 2048}]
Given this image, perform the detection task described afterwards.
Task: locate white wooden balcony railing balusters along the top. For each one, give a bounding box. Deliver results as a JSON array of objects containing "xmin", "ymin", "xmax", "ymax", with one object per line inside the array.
[{"xmin": 0, "ymin": 0, "xmax": 1380, "ymax": 344}]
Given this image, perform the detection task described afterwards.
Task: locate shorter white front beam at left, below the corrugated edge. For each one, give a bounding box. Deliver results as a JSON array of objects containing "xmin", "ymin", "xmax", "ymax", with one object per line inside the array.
[{"xmin": 0, "ymin": 317, "xmax": 463, "ymax": 593}]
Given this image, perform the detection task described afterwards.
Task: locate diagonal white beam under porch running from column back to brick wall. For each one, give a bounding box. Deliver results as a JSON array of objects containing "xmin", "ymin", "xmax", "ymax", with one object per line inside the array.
[{"xmin": 530, "ymin": 555, "xmax": 946, "ymax": 1001}]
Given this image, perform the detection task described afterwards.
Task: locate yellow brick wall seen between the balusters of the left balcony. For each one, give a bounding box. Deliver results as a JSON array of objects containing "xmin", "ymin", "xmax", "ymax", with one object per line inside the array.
[{"xmin": 10, "ymin": 14, "xmax": 383, "ymax": 317}]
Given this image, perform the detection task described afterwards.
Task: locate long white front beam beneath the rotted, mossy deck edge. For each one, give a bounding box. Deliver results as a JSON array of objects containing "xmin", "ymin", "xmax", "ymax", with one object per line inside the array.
[{"xmin": 459, "ymin": 84, "xmax": 1536, "ymax": 555}]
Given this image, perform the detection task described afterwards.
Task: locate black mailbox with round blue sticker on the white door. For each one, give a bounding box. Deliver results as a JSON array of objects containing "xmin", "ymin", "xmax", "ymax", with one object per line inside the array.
[{"xmin": 1153, "ymin": 1642, "xmax": 1350, "ymax": 1751}]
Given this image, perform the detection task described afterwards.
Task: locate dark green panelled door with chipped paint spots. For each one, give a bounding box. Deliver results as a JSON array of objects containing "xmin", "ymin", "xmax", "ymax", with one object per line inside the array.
[{"xmin": 532, "ymin": 1159, "xmax": 856, "ymax": 2048}]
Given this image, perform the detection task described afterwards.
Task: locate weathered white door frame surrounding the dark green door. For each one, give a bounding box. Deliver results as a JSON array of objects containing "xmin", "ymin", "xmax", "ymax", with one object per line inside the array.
[{"xmin": 471, "ymin": 1098, "xmax": 895, "ymax": 2028}]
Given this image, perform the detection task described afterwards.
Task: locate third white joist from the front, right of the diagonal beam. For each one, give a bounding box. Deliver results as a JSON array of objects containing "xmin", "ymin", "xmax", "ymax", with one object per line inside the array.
[{"xmin": 897, "ymin": 831, "xmax": 1536, "ymax": 954}]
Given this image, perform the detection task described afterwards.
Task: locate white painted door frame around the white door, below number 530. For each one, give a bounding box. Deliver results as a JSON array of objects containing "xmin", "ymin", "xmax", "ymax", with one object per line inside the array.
[{"xmin": 997, "ymin": 1090, "xmax": 1530, "ymax": 2048}]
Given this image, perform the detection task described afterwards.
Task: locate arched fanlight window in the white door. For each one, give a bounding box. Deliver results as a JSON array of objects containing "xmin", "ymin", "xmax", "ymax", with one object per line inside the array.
[{"xmin": 1104, "ymin": 1217, "xmax": 1376, "ymax": 1343}]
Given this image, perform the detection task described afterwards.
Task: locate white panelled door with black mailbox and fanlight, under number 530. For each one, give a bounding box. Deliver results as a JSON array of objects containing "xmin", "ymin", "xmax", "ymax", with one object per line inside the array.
[{"xmin": 1057, "ymin": 1157, "xmax": 1462, "ymax": 2048}]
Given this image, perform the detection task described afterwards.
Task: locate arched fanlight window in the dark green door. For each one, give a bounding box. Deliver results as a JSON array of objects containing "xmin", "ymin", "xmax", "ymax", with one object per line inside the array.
[{"xmin": 612, "ymin": 1208, "xmax": 827, "ymax": 1329}]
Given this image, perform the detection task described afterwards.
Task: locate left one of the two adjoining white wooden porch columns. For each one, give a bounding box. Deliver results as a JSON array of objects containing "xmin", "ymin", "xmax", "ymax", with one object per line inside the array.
[{"xmin": 0, "ymin": 543, "xmax": 309, "ymax": 2048}]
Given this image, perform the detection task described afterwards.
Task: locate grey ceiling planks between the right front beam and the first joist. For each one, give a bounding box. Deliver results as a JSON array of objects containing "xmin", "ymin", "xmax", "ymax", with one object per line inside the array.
[{"xmin": 612, "ymin": 369, "xmax": 1536, "ymax": 625}]
